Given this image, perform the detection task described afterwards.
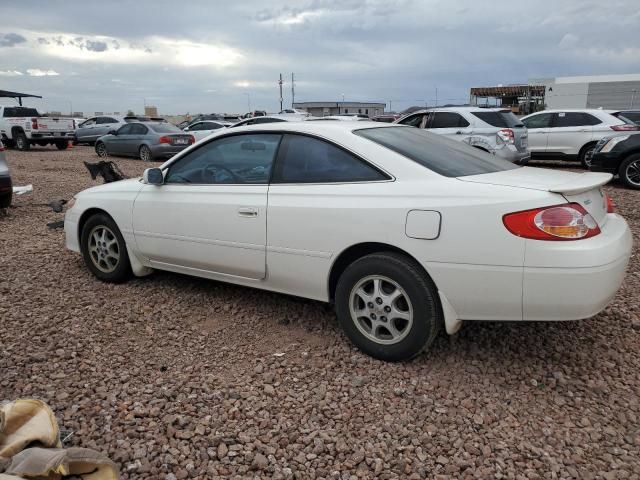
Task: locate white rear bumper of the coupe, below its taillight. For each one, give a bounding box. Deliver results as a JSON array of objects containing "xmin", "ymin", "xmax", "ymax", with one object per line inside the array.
[{"xmin": 522, "ymin": 214, "xmax": 633, "ymax": 320}]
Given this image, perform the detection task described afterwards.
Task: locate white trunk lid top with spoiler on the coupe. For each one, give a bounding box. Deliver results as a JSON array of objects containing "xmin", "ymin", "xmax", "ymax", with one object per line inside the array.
[{"xmin": 458, "ymin": 167, "xmax": 613, "ymax": 195}]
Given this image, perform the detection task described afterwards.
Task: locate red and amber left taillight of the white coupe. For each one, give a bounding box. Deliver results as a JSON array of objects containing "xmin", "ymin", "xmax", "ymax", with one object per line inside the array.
[{"xmin": 502, "ymin": 203, "xmax": 600, "ymax": 240}]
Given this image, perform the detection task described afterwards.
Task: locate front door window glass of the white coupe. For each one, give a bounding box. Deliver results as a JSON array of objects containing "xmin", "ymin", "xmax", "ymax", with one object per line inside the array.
[{"xmin": 165, "ymin": 133, "xmax": 282, "ymax": 185}]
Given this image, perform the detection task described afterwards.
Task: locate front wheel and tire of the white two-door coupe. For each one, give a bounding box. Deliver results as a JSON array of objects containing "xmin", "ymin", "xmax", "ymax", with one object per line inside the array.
[{"xmin": 80, "ymin": 213, "xmax": 131, "ymax": 283}]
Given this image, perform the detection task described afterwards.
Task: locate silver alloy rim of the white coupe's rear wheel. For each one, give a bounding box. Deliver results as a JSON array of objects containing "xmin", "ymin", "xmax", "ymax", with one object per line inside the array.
[{"xmin": 349, "ymin": 275, "xmax": 413, "ymax": 345}]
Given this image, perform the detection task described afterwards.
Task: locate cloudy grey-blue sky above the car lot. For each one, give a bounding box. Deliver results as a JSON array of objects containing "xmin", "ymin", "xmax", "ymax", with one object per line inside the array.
[{"xmin": 0, "ymin": 0, "xmax": 640, "ymax": 114}]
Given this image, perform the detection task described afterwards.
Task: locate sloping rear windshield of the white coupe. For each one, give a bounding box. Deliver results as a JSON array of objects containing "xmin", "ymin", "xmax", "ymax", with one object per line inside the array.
[{"xmin": 353, "ymin": 127, "xmax": 519, "ymax": 177}]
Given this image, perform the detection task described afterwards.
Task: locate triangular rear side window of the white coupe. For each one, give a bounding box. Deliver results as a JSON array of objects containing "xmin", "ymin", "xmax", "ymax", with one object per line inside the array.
[{"xmin": 272, "ymin": 135, "xmax": 389, "ymax": 183}]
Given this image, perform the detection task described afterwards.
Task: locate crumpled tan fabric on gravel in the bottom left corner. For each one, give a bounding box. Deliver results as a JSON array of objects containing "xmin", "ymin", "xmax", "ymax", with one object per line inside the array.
[{"xmin": 0, "ymin": 400, "xmax": 119, "ymax": 480}]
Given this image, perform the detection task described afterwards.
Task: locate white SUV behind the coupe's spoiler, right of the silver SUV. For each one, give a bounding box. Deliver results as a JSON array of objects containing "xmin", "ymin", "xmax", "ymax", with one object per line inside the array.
[{"xmin": 521, "ymin": 109, "xmax": 640, "ymax": 168}]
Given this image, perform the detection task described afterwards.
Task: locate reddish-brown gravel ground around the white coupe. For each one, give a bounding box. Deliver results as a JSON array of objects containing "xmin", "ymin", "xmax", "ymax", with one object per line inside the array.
[{"xmin": 0, "ymin": 147, "xmax": 640, "ymax": 480}]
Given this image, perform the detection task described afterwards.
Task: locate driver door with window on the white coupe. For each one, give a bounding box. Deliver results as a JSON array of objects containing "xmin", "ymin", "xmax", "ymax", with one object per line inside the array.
[{"xmin": 133, "ymin": 134, "xmax": 281, "ymax": 280}]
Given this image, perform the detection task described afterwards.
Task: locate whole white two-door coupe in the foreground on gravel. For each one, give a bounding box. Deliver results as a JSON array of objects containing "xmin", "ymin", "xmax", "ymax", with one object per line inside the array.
[{"xmin": 65, "ymin": 122, "xmax": 632, "ymax": 360}]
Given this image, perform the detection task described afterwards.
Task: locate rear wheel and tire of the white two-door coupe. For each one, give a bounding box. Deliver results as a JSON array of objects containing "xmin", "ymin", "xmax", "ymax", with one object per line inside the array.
[{"xmin": 335, "ymin": 252, "xmax": 443, "ymax": 362}]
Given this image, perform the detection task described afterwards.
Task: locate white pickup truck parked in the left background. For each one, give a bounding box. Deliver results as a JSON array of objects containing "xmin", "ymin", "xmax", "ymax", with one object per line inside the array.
[{"xmin": 0, "ymin": 106, "xmax": 75, "ymax": 150}]
